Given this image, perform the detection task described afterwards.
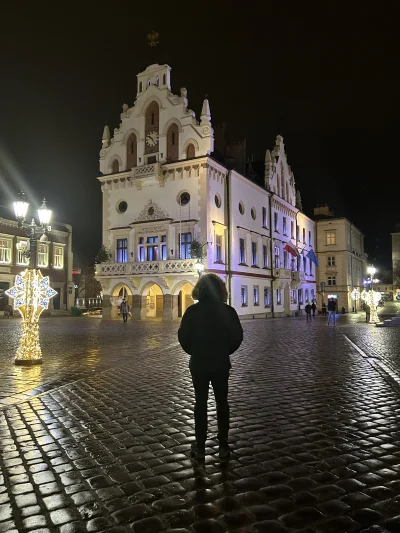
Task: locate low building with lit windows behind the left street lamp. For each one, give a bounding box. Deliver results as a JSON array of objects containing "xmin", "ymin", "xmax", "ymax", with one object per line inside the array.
[{"xmin": 0, "ymin": 214, "xmax": 75, "ymax": 313}]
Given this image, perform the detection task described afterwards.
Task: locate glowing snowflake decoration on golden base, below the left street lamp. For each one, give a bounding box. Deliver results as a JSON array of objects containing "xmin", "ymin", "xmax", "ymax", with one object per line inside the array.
[{"xmin": 5, "ymin": 269, "xmax": 57, "ymax": 365}]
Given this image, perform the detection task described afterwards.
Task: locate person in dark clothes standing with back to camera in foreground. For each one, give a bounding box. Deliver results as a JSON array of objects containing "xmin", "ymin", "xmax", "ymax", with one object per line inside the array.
[{"xmin": 178, "ymin": 274, "xmax": 243, "ymax": 459}]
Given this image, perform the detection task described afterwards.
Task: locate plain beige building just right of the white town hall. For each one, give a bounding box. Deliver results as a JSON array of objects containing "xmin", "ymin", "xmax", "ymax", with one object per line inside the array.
[{"xmin": 314, "ymin": 206, "xmax": 367, "ymax": 312}]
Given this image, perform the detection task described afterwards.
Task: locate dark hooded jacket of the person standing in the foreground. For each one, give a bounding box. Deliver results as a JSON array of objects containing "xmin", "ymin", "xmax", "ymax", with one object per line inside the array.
[{"xmin": 178, "ymin": 278, "xmax": 243, "ymax": 372}]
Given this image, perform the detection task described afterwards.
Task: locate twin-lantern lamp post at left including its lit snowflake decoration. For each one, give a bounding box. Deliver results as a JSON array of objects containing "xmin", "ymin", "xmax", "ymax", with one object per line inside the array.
[{"xmin": 6, "ymin": 193, "xmax": 57, "ymax": 365}]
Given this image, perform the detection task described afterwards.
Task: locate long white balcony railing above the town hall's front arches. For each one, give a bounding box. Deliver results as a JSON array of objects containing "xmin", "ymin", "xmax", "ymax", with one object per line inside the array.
[{"xmin": 96, "ymin": 259, "xmax": 197, "ymax": 277}]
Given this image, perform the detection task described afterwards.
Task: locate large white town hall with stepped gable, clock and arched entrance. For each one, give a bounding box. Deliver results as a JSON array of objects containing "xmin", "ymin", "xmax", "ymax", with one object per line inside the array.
[{"xmin": 96, "ymin": 65, "xmax": 316, "ymax": 320}]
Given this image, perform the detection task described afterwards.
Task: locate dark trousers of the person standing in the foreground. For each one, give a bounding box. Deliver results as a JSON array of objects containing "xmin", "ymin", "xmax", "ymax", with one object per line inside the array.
[{"xmin": 191, "ymin": 370, "xmax": 229, "ymax": 446}]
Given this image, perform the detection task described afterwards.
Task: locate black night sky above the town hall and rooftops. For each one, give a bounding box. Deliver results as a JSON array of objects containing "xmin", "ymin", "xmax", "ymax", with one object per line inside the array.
[{"xmin": 0, "ymin": 0, "xmax": 400, "ymax": 267}]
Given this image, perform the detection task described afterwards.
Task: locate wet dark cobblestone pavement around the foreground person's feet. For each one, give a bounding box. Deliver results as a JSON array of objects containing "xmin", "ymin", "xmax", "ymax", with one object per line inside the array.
[{"xmin": 0, "ymin": 319, "xmax": 400, "ymax": 533}]
